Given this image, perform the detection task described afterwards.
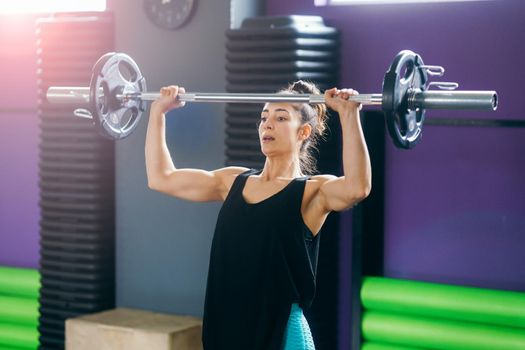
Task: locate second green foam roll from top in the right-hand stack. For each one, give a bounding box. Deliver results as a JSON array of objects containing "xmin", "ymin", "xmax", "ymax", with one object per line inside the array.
[{"xmin": 361, "ymin": 311, "xmax": 525, "ymax": 350}]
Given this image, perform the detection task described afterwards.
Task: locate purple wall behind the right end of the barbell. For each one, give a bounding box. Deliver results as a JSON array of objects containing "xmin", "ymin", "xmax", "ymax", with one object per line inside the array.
[{"xmin": 267, "ymin": 0, "xmax": 525, "ymax": 349}]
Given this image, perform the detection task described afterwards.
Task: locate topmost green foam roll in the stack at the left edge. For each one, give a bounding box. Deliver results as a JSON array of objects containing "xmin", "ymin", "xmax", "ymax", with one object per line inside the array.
[{"xmin": 0, "ymin": 266, "xmax": 40, "ymax": 299}]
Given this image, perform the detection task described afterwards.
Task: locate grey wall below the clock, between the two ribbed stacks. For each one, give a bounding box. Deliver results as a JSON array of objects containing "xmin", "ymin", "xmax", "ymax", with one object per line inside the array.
[{"xmin": 108, "ymin": 0, "xmax": 230, "ymax": 316}]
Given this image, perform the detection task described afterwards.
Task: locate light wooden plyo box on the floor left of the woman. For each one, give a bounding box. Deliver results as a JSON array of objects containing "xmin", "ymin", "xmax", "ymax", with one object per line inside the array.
[{"xmin": 66, "ymin": 308, "xmax": 202, "ymax": 350}]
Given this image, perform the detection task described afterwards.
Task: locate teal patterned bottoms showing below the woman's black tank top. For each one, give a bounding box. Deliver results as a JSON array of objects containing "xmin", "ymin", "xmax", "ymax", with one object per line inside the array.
[{"xmin": 283, "ymin": 304, "xmax": 315, "ymax": 350}]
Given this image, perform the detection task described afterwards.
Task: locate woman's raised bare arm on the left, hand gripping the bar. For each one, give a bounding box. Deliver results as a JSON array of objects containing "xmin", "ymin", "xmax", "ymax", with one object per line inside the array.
[{"xmin": 145, "ymin": 86, "xmax": 246, "ymax": 202}]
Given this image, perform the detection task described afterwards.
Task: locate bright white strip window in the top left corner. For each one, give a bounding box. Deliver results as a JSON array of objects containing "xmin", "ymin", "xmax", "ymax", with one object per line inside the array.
[{"xmin": 0, "ymin": 0, "xmax": 106, "ymax": 14}]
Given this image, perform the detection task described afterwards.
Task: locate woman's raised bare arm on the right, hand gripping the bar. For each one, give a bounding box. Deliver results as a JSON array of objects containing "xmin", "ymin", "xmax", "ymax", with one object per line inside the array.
[{"xmin": 318, "ymin": 88, "xmax": 372, "ymax": 212}]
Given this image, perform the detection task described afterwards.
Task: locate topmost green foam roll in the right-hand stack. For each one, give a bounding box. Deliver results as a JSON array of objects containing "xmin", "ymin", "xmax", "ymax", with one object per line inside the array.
[{"xmin": 361, "ymin": 277, "xmax": 525, "ymax": 332}]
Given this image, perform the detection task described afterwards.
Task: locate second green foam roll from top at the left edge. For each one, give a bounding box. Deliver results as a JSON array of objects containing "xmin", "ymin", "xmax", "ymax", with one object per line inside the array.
[{"xmin": 0, "ymin": 295, "xmax": 39, "ymax": 328}]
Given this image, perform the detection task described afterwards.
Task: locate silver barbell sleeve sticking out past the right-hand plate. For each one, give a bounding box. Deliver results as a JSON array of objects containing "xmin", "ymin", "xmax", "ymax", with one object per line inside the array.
[{"xmin": 408, "ymin": 90, "xmax": 498, "ymax": 111}]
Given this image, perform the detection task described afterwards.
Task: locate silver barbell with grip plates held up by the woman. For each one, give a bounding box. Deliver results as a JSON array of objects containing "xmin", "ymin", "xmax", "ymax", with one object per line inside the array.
[{"xmin": 46, "ymin": 50, "xmax": 498, "ymax": 149}]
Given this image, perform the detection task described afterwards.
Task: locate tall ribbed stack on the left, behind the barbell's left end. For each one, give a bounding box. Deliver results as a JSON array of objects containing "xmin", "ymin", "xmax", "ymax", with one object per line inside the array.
[{"xmin": 36, "ymin": 13, "xmax": 115, "ymax": 349}]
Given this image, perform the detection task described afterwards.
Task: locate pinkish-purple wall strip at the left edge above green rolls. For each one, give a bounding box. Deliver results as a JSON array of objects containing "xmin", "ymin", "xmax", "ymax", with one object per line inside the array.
[{"xmin": 0, "ymin": 15, "xmax": 40, "ymax": 268}]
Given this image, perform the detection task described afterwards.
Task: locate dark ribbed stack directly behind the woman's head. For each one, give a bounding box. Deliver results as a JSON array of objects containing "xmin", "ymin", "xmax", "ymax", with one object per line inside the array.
[{"xmin": 226, "ymin": 16, "xmax": 339, "ymax": 168}]
